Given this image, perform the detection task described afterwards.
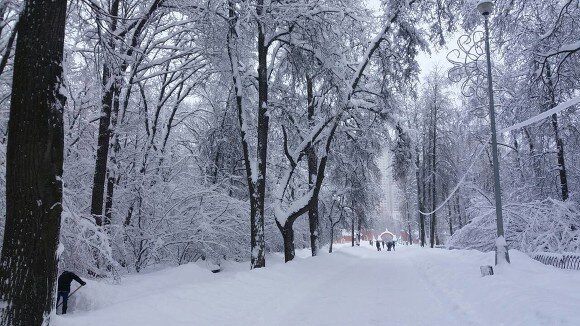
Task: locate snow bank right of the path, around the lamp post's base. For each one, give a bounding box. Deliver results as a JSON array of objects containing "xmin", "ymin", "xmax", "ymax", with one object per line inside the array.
[{"xmin": 414, "ymin": 250, "xmax": 580, "ymax": 325}]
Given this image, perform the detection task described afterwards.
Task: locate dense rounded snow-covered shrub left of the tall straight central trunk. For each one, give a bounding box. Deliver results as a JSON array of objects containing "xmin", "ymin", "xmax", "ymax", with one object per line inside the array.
[{"xmin": 116, "ymin": 173, "xmax": 250, "ymax": 271}]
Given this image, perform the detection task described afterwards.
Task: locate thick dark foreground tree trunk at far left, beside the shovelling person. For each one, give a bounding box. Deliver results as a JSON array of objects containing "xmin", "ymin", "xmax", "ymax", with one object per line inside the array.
[{"xmin": 0, "ymin": 0, "xmax": 66, "ymax": 326}]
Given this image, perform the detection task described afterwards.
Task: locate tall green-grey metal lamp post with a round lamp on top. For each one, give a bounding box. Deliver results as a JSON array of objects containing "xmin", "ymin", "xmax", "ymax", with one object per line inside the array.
[{"xmin": 477, "ymin": 0, "xmax": 510, "ymax": 265}]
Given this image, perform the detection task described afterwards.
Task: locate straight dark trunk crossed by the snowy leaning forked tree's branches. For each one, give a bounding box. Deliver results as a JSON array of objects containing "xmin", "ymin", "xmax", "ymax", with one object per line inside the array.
[{"xmin": 306, "ymin": 77, "xmax": 320, "ymax": 256}]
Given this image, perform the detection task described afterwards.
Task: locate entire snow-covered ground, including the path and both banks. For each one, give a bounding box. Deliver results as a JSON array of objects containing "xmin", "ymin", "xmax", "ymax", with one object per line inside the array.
[{"xmin": 53, "ymin": 244, "xmax": 580, "ymax": 326}]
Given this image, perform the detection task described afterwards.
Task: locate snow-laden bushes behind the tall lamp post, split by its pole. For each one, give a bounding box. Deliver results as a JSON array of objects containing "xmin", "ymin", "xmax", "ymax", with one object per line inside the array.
[{"xmin": 447, "ymin": 199, "xmax": 580, "ymax": 253}]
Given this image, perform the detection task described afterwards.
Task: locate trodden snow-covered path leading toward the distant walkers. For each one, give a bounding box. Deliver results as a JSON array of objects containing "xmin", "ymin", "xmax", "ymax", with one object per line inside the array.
[{"xmin": 281, "ymin": 248, "xmax": 465, "ymax": 325}]
